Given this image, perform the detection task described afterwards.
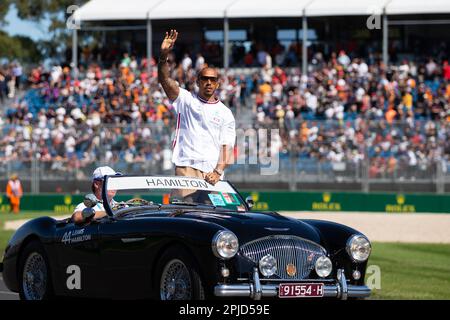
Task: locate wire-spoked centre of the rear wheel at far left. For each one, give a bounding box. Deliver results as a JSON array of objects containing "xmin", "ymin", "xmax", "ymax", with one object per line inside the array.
[{"xmin": 22, "ymin": 252, "xmax": 47, "ymax": 300}]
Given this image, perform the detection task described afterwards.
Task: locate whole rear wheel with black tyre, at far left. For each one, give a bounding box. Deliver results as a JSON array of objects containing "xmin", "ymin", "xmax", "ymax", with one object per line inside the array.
[{"xmin": 18, "ymin": 241, "xmax": 53, "ymax": 300}]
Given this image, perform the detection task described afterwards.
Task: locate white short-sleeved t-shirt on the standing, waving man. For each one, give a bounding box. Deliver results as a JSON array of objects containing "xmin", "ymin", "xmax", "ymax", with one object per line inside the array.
[{"xmin": 172, "ymin": 88, "xmax": 236, "ymax": 172}]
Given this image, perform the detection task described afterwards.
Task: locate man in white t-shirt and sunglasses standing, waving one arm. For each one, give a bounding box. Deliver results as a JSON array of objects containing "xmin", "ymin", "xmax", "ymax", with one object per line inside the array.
[{"xmin": 158, "ymin": 30, "xmax": 236, "ymax": 185}]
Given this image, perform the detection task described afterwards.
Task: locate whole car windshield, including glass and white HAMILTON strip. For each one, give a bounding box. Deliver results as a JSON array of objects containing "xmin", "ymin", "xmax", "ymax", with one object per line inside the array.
[{"xmin": 104, "ymin": 176, "xmax": 246, "ymax": 214}]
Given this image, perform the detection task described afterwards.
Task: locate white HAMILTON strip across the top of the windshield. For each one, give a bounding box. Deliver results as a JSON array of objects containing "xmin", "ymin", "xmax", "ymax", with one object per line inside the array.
[{"xmin": 107, "ymin": 177, "xmax": 236, "ymax": 193}]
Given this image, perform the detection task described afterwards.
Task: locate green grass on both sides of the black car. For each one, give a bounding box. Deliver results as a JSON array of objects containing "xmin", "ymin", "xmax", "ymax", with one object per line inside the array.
[{"xmin": 0, "ymin": 212, "xmax": 450, "ymax": 299}]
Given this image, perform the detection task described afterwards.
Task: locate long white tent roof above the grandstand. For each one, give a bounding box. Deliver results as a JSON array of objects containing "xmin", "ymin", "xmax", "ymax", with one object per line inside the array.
[{"xmin": 75, "ymin": 0, "xmax": 450, "ymax": 21}]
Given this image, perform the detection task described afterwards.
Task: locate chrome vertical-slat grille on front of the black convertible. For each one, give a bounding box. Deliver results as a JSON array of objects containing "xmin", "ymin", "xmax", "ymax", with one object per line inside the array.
[{"xmin": 240, "ymin": 235, "xmax": 326, "ymax": 280}]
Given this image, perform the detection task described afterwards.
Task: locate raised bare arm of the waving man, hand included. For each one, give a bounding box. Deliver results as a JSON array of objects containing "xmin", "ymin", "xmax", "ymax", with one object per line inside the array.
[{"xmin": 158, "ymin": 30, "xmax": 180, "ymax": 101}]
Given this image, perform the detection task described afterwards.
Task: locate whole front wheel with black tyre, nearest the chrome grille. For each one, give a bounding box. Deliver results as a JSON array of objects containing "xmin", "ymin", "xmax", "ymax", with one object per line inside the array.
[{"xmin": 155, "ymin": 246, "xmax": 205, "ymax": 300}]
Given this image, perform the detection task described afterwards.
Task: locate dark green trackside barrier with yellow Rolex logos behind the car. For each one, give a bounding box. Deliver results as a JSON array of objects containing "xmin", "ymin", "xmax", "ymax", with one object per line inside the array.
[{"xmin": 0, "ymin": 191, "xmax": 450, "ymax": 214}]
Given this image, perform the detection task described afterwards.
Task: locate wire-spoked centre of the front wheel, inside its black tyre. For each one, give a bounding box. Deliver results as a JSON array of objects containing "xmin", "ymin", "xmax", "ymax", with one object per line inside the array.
[{"xmin": 160, "ymin": 259, "xmax": 192, "ymax": 300}]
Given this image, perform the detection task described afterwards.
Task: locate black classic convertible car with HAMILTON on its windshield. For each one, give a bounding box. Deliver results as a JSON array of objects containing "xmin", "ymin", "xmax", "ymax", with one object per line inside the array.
[{"xmin": 3, "ymin": 176, "xmax": 371, "ymax": 300}]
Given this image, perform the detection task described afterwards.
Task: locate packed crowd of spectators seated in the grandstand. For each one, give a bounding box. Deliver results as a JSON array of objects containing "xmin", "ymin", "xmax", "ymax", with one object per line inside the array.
[{"xmin": 0, "ymin": 46, "xmax": 450, "ymax": 177}]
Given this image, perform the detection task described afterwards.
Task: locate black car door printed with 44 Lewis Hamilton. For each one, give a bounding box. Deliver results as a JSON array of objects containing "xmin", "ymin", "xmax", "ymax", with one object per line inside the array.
[{"xmin": 55, "ymin": 221, "xmax": 101, "ymax": 297}]
